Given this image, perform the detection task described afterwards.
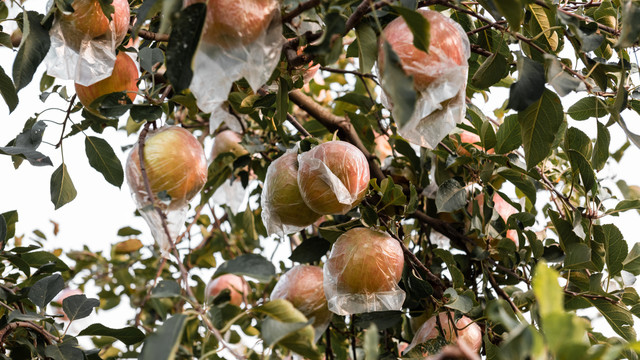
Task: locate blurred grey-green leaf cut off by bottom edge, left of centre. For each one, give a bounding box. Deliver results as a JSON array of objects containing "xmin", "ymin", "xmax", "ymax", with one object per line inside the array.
[{"xmin": 139, "ymin": 314, "xmax": 189, "ymax": 360}]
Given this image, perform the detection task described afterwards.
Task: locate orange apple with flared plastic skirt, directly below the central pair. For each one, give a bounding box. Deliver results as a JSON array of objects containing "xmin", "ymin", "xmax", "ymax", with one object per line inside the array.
[{"xmin": 324, "ymin": 228, "xmax": 405, "ymax": 315}]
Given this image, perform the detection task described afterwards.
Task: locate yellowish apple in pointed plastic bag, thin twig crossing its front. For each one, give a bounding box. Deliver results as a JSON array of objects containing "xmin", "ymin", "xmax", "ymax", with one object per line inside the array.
[{"xmin": 126, "ymin": 126, "xmax": 207, "ymax": 256}]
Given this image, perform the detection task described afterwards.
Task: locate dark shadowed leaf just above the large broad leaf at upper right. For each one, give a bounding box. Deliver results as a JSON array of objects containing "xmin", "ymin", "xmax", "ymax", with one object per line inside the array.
[{"xmin": 507, "ymin": 54, "xmax": 549, "ymax": 111}]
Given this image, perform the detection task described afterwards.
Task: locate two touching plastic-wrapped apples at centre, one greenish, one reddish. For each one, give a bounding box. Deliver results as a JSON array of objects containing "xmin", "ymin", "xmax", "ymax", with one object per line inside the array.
[{"xmin": 262, "ymin": 141, "xmax": 369, "ymax": 233}]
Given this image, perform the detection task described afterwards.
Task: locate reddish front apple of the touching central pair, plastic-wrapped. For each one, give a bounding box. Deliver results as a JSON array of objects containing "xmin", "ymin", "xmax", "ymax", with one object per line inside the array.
[{"xmin": 298, "ymin": 141, "xmax": 369, "ymax": 215}]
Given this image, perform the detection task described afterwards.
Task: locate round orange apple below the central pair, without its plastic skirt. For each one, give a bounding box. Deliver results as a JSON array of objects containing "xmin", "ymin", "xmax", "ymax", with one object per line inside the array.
[{"xmin": 324, "ymin": 228, "xmax": 404, "ymax": 295}]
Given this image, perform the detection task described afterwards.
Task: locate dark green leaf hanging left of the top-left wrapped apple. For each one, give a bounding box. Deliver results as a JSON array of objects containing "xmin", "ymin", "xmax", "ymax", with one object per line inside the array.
[{"xmin": 13, "ymin": 11, "xmax": 51, "ymax": 91}]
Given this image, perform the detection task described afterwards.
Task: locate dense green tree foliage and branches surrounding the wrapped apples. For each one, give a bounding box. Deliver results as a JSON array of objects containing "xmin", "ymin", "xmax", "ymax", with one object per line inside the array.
[{"xmin": 0, "ymin": 0, "xmax": 640, "ymax": 360}]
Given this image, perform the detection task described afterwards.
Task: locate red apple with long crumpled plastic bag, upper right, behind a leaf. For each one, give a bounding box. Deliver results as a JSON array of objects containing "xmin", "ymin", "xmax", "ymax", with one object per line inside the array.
[{"xmin": 378, "ymin": 9, "xmax": 471, "ymax": 149}]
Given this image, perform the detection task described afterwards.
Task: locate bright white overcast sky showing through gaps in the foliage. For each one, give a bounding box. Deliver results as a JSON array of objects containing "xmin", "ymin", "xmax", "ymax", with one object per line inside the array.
[{"xmin": 0, "ymin": 1, "xmax": 640, "ymax": 352}]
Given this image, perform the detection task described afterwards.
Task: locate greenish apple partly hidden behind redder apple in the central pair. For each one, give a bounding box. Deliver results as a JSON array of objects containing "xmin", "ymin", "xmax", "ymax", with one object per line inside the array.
[{"xmin": 261, "ymin": 152, "xmax": 321, "ymax": 232}]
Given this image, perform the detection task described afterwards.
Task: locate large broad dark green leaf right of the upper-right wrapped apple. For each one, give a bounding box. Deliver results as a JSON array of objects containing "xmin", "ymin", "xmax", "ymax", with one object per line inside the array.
[{"xmin": 518, "ymin": 90, "xmax": 564, "ymax": 169}]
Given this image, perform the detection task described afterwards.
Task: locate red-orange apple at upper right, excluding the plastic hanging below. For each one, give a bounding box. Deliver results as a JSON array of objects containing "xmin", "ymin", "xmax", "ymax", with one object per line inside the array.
[{"xmin": 378, "ymin": 9, "xmax": 467, "ymax": 90}]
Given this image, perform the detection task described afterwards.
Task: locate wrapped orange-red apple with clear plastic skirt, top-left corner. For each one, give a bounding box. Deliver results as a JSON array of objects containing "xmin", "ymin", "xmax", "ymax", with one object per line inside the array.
[{"xmin": 45, "ymin": 0, "xmax": 129, "ymax": 86}]
